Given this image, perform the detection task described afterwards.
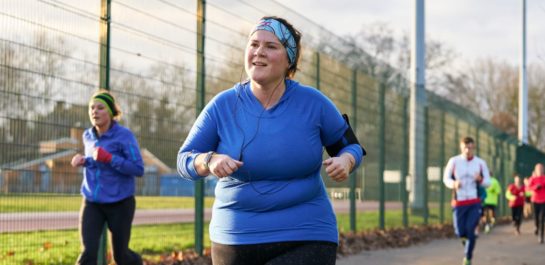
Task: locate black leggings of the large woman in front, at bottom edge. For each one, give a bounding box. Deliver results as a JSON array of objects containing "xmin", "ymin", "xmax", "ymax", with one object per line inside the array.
[{"xmin": 212, "ymin": 241, "xmax": 337, "ymax": 265}]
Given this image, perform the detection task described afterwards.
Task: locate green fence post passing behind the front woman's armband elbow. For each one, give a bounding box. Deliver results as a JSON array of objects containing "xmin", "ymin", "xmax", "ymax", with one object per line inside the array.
[{"xmin": 350, "ymin": 69, "xmax": 358, "ymax": 232}]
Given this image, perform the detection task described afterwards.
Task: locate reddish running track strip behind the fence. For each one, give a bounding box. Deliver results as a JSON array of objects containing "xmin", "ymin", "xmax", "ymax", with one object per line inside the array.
[{"xmin": 0, "ymin": 200, "xmax": 401, "ymax": 233}]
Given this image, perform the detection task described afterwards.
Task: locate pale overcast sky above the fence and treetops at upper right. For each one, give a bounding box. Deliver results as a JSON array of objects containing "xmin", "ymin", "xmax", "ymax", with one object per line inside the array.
[{"xmin": 277, "ymin": 0, "xmax": 545, "ymax": 64}]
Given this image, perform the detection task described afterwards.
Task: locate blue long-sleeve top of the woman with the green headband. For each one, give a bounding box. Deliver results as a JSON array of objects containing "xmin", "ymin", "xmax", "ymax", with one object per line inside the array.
[{"xmin": 81, "ymin": 121, "xmax": 144, "ymax": 203}]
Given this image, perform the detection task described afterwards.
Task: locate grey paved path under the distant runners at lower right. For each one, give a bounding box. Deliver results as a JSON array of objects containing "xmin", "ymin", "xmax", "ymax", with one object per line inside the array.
[{"xmin": 337, "ymin": 220, "xmax": 545, "ymax": 265}]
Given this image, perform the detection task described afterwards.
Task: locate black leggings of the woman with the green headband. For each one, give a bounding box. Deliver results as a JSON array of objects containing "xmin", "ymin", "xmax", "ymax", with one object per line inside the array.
[{"xmin": 76, "ymin": 196, "xmax": 142, "ymax": 265}]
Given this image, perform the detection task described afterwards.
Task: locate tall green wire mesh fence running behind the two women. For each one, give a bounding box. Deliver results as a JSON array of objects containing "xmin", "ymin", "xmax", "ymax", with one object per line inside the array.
[{"xmin": 0, "ymin": 0, "xmax": 544, "ymax": 264}]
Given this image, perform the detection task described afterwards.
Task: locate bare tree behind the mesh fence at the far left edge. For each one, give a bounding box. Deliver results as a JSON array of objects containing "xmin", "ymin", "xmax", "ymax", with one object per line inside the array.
[{"xmin": 0, "ymin": 30, "xmax": 78, "ymax": 163}]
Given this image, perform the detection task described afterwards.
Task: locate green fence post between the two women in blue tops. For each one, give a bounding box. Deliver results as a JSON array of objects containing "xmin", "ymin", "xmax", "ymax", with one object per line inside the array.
[{"xmin": 195, "ymin": 0, "xmax": 206, "ymax": 255}]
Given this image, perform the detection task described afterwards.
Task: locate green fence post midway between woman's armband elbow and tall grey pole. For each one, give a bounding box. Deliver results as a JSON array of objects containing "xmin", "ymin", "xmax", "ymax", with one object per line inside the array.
[{"xmin": 378, "ymin": 77, "xmax": 386, "ymax": 229}]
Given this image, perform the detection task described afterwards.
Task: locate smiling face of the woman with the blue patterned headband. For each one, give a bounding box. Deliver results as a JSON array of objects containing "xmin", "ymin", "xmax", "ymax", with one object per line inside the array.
[{"xmin": 244, "ymin": 30, "xmax": 289, "ymax": 86}]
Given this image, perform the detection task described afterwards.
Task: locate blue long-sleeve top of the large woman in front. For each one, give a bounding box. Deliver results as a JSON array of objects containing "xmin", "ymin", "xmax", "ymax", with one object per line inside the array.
[{"xmin": 177, "ymin": 80, "xmax": 363, "ymax": 244}]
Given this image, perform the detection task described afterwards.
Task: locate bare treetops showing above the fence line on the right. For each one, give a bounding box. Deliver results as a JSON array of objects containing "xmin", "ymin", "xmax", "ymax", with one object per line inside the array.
[{"xmin": 319, "ymin": 22, "xmax": 545, "ymax": 150}]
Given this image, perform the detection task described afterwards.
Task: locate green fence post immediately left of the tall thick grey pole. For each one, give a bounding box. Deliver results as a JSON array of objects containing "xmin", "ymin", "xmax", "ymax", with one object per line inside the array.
[{"xmin": 400, "ymin": 97, "xmax": 409, "ymax": 227}]
